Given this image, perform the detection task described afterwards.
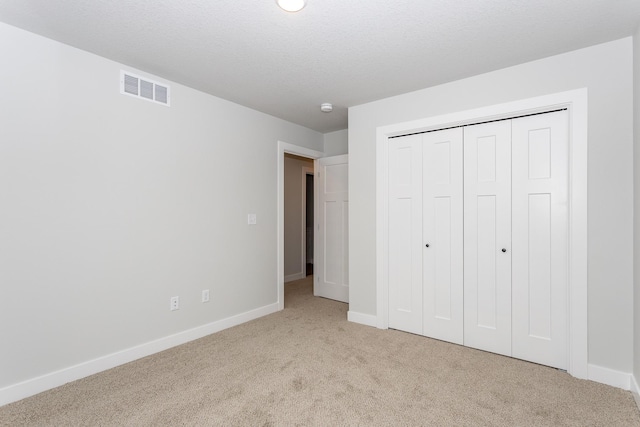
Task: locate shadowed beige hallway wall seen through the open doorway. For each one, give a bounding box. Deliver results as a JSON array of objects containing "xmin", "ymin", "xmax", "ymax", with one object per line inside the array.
[{"xmin": 284, "ymin": 154, "xmax": 313, "ymax": 281}]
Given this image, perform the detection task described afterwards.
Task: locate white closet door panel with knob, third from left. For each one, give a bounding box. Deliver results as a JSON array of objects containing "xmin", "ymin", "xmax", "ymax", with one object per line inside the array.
[{"xmin": 464, "ymin": 120, "xmax": 511, "ymax": 355}]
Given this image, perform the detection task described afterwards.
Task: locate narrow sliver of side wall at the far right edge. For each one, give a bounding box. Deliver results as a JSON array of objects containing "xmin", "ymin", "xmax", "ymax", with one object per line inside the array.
[{"xmin": 633, "ymin": 28, "xmax": 640, "ymax": 388}]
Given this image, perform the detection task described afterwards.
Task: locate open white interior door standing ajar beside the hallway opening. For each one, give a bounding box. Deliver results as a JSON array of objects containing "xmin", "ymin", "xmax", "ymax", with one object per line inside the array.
[{"xmin": 313, "ymin": 154, "xmax": 349, "ymax": 302}]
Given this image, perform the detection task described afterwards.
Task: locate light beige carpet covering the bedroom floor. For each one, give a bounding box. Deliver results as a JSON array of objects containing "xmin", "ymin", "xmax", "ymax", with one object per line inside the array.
[{"xmin": 0, "ymin": 278, "xmax": 640, "ymax": 426}]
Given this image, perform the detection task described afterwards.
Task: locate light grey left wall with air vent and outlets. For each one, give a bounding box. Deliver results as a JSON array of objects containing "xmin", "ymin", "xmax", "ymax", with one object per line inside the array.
[{"xmin": 0, "ymin": 24, "xmax": 324, "ymax": 390}]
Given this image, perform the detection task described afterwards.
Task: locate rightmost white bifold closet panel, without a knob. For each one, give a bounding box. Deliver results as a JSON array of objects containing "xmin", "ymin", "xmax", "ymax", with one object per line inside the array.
[{"xmin": 512, "ymin": 111, "xmax": 569, "ymax": 369}]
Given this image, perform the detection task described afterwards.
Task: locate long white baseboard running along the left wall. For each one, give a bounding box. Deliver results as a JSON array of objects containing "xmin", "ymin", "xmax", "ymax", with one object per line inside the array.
[{"xmin": 0, "ymin": 303, "xmax": 278, "ymax": 406}]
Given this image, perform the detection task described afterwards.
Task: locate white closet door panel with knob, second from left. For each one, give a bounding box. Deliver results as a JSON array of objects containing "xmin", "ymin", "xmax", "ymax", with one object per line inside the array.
[{"xmin": 422, "ymin": 128, "xmax": 463, "ymax": 344}]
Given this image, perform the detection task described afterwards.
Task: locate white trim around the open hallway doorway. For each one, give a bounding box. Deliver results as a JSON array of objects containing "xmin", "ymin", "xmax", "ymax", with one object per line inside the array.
[{"xmin": 276, "ymin": 141, "xmax": 324, "ymax": 310}]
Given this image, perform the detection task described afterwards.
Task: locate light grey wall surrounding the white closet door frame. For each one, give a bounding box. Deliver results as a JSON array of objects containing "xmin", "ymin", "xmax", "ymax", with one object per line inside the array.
[{"xmin": 349, "ymin": 38, "xmax": 633, "ymax": 372}]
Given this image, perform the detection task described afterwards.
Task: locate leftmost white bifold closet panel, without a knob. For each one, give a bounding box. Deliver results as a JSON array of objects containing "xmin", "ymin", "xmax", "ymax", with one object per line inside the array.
[{"xmin": 388, "ymin": 135, "xmax": 422, "ymax": 334}]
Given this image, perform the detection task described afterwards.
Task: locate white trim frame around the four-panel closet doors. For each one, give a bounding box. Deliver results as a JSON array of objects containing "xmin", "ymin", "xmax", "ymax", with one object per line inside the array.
[{"xmin": 376, "ymin": 88, "xmax": 588, "ymax": 379}]
